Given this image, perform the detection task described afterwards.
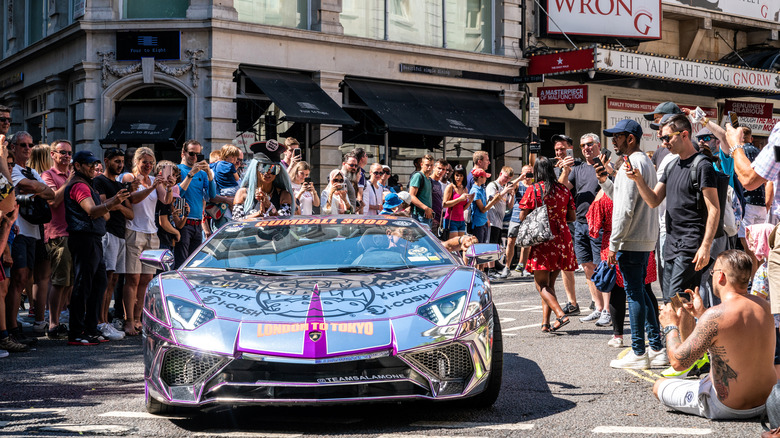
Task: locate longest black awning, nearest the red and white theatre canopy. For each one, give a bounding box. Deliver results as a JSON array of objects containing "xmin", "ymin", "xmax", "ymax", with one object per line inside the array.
[{"xmin": 347, "ymin": 79, "xmax": 528, "ymax": 142}]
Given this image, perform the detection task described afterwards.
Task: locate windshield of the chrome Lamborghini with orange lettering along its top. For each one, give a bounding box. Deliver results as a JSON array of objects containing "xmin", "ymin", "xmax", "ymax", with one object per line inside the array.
[{"xmin": 184, "ymin": 217, "xmax": 457, "ymax": 275}]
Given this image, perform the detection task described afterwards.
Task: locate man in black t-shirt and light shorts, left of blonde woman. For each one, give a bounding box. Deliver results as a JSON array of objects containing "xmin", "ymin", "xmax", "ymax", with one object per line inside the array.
[{"xmin": 92, "ymin": 148, "xmax": 140, "ymax": 337}]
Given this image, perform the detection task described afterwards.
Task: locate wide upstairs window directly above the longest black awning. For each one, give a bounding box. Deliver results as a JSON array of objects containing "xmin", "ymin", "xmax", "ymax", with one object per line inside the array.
[{"xmin": 341, "ymin": 0, "xmax": 494, "ymax": 53}]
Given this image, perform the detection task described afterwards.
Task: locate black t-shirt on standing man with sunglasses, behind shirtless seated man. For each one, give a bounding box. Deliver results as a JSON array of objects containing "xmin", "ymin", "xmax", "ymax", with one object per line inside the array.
[{"xmin": 659, "ymin": 153, "xmax": 717, "ymax": 260}]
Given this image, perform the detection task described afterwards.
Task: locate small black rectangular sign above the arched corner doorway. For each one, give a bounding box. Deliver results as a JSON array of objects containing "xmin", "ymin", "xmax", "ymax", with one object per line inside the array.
[{"xmin": 116, "ymin": 31, "xmax": 181, "ymax": 61}]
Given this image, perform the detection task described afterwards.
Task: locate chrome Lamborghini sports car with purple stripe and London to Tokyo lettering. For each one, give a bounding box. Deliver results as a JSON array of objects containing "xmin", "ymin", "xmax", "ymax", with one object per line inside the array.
[{"xmin": 141, "ymin": 216, "xmax": 503, "ymax": 413}]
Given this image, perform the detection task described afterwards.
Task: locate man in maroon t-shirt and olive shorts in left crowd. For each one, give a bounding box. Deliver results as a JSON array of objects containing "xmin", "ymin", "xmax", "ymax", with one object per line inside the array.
[{"xmin": 39, "ymin": 140, "xmax": 73, "ymax": 339}]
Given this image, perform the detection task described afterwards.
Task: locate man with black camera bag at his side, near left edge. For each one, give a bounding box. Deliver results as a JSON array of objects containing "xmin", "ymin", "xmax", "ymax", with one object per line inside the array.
[{"xmin": 5, "ymin": 131, "xmax": 54, "ymax": 345}]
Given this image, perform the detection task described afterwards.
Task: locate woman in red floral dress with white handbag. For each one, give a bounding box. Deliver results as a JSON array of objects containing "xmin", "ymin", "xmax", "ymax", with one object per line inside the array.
[{"xmin": 519, "ymin": 157, "xmax": 577, "ymax": 332}]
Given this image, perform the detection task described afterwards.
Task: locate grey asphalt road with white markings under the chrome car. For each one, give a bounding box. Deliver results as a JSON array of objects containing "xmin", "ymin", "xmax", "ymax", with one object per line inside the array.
[{"xmin": 0, "ymin": 274, "xmax": 761, "ymax": 438}]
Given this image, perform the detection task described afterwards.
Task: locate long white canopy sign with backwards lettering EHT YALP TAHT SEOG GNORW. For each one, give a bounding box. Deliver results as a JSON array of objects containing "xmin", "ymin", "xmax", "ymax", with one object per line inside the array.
[{"xmin": 596, "ymin": 47, "xmax": 780, "ymax": 94}]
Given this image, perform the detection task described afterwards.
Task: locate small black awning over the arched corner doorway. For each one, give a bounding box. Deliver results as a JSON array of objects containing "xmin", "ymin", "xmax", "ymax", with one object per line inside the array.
[{"xmin": 100, "ymin": 102, "xmax": 184, "ymax": 144}]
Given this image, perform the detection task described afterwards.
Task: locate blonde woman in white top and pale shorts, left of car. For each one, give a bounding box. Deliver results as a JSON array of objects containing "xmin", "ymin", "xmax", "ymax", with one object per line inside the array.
[{"xmin": 122, "ymin": 147, "xmax": 175, "ymax": 336}]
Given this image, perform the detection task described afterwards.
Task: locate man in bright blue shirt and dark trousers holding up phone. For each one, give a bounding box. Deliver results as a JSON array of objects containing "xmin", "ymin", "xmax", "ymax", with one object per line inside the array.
[{"xmin": 173, "ymin": 140, "xmax": 217, "ymax": 268}]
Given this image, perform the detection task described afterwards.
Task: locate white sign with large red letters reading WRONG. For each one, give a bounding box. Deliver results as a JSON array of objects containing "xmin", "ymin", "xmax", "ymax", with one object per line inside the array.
[{"xmin": 547, "ymin": 0, "xmax": 661, "ymax": 40}]
